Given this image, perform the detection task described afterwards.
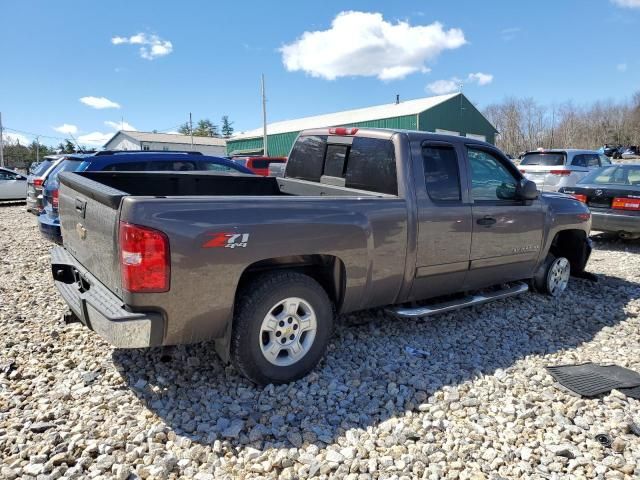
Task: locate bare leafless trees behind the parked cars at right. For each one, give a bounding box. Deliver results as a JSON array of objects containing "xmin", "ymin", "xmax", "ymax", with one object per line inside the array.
[{"xmin": 483, "ymin": 91, "xmax": 640, "ymax": 156}]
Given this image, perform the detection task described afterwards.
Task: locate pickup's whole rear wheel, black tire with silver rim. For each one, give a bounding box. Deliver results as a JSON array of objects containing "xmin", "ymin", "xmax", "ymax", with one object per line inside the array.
[{"xmin": 231, "ymin": 272, "xmax": 333, "ymax": 385}]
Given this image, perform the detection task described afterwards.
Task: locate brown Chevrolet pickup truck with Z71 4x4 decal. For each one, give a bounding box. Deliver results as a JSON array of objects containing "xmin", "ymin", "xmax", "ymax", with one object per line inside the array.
[{"xmin": 52, "ymin": 128, "xmax": 591, "ymax": 383}]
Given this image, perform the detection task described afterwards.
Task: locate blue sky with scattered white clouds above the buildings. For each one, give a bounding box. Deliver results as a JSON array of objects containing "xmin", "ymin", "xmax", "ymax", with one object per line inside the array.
[{"xmin": 0, "ymin": 0, "xmax": 640, "ymax": 146}]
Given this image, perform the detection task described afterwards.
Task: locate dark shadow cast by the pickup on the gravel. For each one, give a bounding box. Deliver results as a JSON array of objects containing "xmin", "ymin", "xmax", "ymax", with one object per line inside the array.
[{"xmin": 113, "ymin": 275, "xmax": 640, "ymax": 449}]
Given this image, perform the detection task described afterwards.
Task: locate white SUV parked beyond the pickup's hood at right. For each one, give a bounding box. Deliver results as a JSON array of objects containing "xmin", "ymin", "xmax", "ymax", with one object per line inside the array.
[{"xmin": 518, "ymin": 149, "xmax": 611, "ymax": 192}]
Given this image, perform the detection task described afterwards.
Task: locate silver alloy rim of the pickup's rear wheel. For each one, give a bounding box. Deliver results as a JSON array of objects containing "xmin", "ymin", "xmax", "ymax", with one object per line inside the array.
[{"xmin": 258, "ymin": 297, "xmax": 318, "ymax": 367}]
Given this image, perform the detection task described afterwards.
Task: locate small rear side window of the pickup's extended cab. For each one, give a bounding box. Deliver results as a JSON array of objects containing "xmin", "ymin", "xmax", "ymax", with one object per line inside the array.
[{"xmin": 422, "ymin": 145, "xmax": 460, "ymax": 202}]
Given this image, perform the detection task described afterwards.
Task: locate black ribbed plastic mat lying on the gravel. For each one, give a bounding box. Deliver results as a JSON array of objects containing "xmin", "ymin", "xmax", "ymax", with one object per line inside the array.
[{"xmin": 547, "ymin": 363, "xmax": 640, "ymax": 398}]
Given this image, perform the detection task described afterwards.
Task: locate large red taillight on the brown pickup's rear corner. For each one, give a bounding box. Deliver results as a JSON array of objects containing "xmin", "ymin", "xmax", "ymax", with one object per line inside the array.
[{"xmin": 120, "ymin": 222, "xmax": 171, "ymax": 293}]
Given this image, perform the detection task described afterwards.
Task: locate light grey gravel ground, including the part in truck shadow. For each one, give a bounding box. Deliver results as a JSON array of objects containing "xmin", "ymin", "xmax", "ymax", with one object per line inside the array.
[{"xmin": 0, "ymin": 206, "xmax": 640, "ymax": 480}]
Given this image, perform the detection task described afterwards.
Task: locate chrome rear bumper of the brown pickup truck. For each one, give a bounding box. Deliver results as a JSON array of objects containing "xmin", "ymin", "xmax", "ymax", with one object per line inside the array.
[{"xmin": 51, "ymin": 247, "xmax": 164, "ymax": 348}]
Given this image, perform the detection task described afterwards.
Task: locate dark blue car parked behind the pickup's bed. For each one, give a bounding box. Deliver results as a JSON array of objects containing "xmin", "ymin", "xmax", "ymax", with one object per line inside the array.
[{"xmin": 38, "ymin": 151, "xmax": 253, "ymax": 243}]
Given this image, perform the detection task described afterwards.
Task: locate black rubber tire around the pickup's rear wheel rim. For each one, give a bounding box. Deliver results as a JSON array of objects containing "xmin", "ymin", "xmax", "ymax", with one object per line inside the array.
[{"xmin": 230, "ymin": 271, "xmax": 334, "ymax": 385}]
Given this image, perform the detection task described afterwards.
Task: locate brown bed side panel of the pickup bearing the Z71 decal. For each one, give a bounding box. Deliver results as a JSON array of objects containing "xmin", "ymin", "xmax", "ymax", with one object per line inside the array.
[{"xmin": 121, "ymin": 196, "xmax": 407, "ymax": 344}]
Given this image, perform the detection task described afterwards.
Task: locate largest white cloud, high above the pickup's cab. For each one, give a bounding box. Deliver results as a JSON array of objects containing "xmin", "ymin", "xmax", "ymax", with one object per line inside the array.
[{"xmin": 280, "ymin": 11, "xmax": 466, "ymax": 80}]
